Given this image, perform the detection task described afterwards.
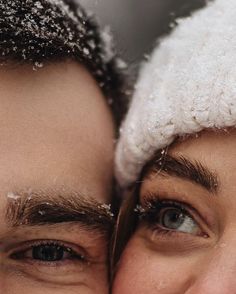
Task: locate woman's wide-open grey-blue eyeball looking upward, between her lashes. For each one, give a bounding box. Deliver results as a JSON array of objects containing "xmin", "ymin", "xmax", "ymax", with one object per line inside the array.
[{"xmin": 157, "ymin": 207, "xmax": 200, "ymax": 235}]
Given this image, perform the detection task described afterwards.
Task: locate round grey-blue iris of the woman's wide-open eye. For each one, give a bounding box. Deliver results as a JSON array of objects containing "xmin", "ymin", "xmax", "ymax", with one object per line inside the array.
[{"xmin": 163, "ymin": 209, "xmax": 185, "ymax": 230}]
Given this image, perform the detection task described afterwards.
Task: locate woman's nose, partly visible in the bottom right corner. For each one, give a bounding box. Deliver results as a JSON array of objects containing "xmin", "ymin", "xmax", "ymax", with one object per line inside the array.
[{"xmin": 186, "ymin": 242, "xmax": 236, "ymax": 294}]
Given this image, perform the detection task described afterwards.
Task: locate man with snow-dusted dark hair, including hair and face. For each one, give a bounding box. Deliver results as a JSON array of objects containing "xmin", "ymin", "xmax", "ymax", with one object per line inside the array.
[{"xmin": 0, "ymin": 0, "xmax": 125, "ymax": 294}]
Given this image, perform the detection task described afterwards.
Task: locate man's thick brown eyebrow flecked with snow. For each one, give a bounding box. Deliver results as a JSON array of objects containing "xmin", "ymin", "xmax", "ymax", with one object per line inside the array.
[{"xmin": 5, "ymin": 191, "xmax": 114, "ymax": 234}]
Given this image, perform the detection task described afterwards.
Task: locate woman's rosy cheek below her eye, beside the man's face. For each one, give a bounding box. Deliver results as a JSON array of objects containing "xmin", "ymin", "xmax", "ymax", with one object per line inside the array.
[{"xmin": 112, "ymin": 238, "xmax": 195, "ymax": 294}]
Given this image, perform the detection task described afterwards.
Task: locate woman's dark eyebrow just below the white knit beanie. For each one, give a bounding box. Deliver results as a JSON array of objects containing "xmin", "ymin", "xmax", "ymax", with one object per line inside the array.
[{"xmin": 142, "ymin": 153, "xmax": 219, "ymax": 193}]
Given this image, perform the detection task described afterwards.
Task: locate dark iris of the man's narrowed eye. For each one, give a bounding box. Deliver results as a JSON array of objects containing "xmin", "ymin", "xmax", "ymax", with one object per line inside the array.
[{"xmin": 33, "ymin": 245, "xmax": 64, "ymax": 261}]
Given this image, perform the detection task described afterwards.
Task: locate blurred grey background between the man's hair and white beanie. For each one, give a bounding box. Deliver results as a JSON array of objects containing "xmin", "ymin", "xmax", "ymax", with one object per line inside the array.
[{"xmin": 78, "ymin": 0, "xmax": 206, "ymax": 67}]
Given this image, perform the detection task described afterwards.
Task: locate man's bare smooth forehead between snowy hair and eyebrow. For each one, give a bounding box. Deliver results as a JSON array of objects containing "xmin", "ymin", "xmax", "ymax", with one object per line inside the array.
[{"xmin": 0, "ymin": 62, "xmax": 113, "ymax": 206}]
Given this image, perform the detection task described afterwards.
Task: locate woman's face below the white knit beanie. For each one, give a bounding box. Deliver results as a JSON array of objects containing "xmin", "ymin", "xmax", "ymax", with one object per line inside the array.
[{"xmin": 113, "ymin": 130, "xmax": 236, "ymax": 294}]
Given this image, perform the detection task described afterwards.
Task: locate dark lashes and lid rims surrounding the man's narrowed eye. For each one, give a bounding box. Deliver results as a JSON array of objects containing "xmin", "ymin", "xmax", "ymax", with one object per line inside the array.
[{"xmin": 10, "ymin": 240, "xmax": 88, "ymax": 266}]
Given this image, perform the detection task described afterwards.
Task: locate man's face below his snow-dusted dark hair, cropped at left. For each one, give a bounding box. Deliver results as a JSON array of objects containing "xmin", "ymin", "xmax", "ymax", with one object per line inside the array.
[{"xmin": 0, "ymin": 62, "xmax": 114, "ymax": 294}]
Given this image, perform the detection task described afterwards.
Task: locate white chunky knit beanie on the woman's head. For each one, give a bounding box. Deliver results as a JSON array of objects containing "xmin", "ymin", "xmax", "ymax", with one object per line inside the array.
[{"xmin": 116, "ymin": 0, "xmax": 236, "ymax": 187}]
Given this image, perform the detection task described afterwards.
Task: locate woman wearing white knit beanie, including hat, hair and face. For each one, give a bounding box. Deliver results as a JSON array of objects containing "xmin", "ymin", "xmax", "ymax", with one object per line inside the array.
[{"xmin": 113, "ymin": 0, "xmax": 236, "ymax": 294}]
